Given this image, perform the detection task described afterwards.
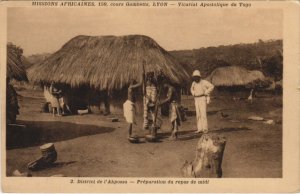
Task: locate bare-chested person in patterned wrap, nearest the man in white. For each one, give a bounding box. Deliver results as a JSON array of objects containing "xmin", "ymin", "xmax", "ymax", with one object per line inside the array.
[{"xmin": 159, "ymin": 82, "xmax": 181, "ymax": 140}]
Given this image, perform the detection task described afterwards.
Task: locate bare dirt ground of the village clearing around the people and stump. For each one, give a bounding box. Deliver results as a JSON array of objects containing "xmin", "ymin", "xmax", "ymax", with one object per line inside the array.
[{"xmin": 7, "ymin": 90, "xmax": 282, "ymax": 177}]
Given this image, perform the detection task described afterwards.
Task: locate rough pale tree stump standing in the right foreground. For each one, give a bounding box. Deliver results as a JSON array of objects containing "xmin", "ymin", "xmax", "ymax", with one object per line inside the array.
[{"xmin": 181, "ymin": 134, "xmax": 226, "ymax": 178}]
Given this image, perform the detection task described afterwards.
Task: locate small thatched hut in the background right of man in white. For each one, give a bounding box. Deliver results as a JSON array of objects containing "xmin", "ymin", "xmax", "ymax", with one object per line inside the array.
[{"xmin": 206, "ymin": 66, "xmax": 265, "ymax": 98}]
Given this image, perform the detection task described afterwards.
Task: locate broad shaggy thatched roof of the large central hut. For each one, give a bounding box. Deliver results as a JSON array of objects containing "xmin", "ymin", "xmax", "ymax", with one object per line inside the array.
[{"xmin": 28, "ymin": 35, "xmax": 189, "ymax": 90}]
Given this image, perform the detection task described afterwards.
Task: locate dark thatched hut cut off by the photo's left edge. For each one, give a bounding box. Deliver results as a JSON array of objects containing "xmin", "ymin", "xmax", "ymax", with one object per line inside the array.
[{"xmin": 6, "ymin": 43, "xmax": 28, "ymax": 124}]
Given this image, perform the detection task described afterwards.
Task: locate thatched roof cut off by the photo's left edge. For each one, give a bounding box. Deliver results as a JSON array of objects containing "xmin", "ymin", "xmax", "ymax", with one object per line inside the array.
[{"xmin": 6, "ymin": 43, "xmax": 28, "ymax": 81}]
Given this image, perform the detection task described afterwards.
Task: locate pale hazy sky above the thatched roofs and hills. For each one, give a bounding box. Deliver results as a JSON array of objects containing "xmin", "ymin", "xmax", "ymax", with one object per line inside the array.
[{"xmin": 7, "ymin": 7, "xmax": 283, "ymax": 56}]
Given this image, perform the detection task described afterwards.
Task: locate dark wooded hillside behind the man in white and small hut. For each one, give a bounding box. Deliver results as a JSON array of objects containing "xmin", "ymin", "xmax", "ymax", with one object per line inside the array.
[{"xmin": 170, "ymin": 40, "xmax": 283, "ymax": 79}]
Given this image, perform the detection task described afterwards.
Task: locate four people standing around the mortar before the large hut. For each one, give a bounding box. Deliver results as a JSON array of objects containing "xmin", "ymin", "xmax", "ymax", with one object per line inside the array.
[{"xmin": 123, "ymin": 70, "xmax": 214, "ymax": 140}]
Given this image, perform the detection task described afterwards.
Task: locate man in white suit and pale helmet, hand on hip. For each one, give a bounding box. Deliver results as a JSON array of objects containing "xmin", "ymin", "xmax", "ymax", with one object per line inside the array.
[{"xmin": 191, "ymin": 70, "xmax": 214, "ymax": 133}]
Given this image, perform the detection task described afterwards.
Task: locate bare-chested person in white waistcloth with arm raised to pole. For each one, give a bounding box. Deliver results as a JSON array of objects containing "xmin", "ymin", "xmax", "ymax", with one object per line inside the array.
[{"xmin": 123, "ymin": 80, "xmax": 142, "ymax": 139}]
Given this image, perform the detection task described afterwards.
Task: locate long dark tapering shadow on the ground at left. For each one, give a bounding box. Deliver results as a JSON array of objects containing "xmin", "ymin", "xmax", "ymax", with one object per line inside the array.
[{"xmin": 6, "ymin": 121, "xmax": 115, "ymax": 149}]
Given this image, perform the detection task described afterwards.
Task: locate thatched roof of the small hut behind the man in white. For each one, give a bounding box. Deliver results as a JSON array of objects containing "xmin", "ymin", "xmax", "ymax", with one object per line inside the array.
[{"xmin": 206, "ymin": 66, "xmax": 265, "ymax": 86}]
